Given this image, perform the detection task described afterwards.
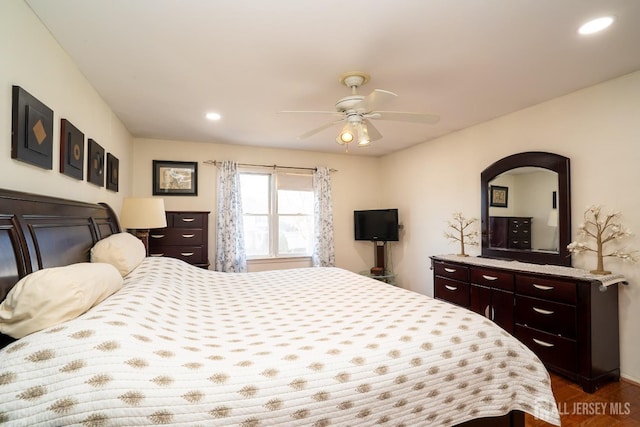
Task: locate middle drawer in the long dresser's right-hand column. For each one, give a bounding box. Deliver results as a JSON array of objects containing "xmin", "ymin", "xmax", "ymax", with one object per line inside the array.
[{"xmin": 515, "ymin": 295, "xmax": 577, "ymax": 339}]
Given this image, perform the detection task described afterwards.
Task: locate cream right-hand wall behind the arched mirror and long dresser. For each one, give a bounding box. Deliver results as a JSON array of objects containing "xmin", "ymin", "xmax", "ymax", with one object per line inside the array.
[{"xmin": 382, "ymin": 72, "xmax": 640, "ymax": 382}]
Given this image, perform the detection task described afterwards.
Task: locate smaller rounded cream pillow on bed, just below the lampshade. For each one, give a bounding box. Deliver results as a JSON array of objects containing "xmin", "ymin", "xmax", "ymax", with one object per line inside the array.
[{"xmin": 91, "ymin": 232, "xmax": 147, "ymax": 277}]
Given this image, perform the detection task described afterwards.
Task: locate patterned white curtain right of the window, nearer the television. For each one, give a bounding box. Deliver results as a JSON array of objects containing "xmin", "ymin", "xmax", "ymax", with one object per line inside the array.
[{"xmin": 313, "ymin": 166, "xmax": 336, "ymax": 267}]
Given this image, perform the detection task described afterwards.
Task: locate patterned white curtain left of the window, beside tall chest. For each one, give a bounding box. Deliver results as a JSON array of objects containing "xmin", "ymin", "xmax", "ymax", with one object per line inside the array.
[{"xmin": 215, "ymin": 160, "xmax": 247, "ymax": 273}]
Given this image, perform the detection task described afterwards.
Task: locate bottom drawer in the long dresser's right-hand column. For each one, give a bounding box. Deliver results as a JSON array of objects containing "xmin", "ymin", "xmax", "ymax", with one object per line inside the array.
[{"xmin": 514, "ymin": 325, "xmax": 580, "ymax": 372}]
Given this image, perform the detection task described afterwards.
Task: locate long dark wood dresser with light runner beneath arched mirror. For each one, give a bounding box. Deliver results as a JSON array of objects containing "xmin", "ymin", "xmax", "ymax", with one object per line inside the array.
[{"xmin": 431, "ymin": 255, "xmax": 625, "ymax": 393}]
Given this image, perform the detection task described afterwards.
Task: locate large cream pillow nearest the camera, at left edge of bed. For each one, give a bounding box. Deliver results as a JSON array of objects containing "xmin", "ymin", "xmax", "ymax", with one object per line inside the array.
[{"xmin": 0, "ymin": 262, "xmax": 122, "ymax": 338}]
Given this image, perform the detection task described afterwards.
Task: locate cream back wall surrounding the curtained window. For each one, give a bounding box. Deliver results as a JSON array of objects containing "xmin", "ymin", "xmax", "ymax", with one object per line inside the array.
[{"xmin": 133, "ymin": 139, "xmax": 384, "ymax": 271}]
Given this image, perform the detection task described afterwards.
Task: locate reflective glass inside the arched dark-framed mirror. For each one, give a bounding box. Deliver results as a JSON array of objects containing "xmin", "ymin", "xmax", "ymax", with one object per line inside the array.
[{"xmin": 487, "ymin": 166, "xmax": 559, "ymax": 253}]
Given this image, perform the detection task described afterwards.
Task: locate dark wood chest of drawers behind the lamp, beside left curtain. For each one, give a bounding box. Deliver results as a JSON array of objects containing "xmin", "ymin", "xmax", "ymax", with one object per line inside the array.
[{"xmin": 149, "ymin": 211, "xmax": 209, "ymax": 268}]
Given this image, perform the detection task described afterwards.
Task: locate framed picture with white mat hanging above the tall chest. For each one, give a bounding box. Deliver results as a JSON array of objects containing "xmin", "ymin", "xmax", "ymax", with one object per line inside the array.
[{"xmin": 153, "ymin": 160, "xmax": 198, "ymax": 196}]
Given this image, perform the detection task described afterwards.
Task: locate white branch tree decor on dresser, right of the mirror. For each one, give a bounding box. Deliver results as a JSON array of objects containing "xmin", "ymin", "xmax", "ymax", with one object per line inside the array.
[{"xmin": 567, "ymin": 205, "xmax": 640, "ymax": 274}]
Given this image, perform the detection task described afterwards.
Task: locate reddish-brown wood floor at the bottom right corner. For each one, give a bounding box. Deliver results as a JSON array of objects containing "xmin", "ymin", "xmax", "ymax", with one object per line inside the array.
[{"xmin": 525, "ymin": 374, "xmax": 640, "ymax": 427}]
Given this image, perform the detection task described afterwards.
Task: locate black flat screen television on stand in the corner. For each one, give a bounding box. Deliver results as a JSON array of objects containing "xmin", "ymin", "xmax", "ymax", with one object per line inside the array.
[{"xmin": 353, "ymin": 209, "xmax": 399, "ymax": 242}]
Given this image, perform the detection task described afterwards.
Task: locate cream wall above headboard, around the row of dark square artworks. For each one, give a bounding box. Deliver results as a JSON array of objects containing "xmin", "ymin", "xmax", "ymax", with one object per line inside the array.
[{"xmin": 0, "ymin": 0, "xmax": 132, "ymax": 211}]
